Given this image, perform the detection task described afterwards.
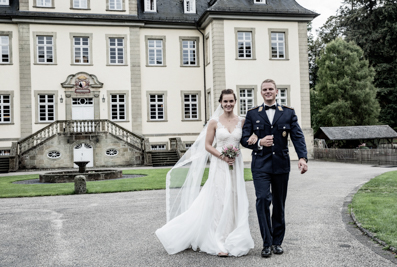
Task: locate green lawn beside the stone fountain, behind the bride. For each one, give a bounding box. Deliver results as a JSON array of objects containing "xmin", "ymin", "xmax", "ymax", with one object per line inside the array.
[{"xmin": 0, "ymin": 168, "xmax": 252, "ymax": 198}]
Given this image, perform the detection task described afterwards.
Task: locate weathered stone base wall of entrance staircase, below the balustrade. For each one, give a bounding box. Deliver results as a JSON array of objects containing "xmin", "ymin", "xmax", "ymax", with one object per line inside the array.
[{"xmin": 20, "ymin": 133, "xmax": 144, "ymax": 169}]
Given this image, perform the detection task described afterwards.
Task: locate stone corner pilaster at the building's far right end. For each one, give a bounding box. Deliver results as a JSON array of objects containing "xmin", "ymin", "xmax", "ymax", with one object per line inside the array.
[{"xmin": 298, "ymin": 22, "xmax": 314, "ymax": 158}]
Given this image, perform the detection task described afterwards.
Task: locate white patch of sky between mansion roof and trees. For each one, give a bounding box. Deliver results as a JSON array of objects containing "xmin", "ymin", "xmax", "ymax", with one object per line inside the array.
[{"xmin": 295, "ymin": 0, "xmax": 342, "ymax": 34}]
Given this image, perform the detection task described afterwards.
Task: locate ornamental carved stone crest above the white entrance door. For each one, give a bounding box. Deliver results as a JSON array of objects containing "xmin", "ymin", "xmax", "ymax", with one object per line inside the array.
[{"xmin": 61, "ymin": 72, "xmax": 103, "ymax": 94}]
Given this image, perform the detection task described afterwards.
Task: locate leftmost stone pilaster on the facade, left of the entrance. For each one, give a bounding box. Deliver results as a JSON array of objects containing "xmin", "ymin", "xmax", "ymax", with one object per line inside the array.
[{"xmin": 18, "ymin": 23, "xmax": 34, "ymax": 138}]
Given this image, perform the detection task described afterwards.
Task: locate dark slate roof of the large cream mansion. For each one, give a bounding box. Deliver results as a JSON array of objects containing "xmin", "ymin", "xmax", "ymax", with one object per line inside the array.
[{"xmin": 0, "ymin": 0, "xmax": 319, "ymax": 27}]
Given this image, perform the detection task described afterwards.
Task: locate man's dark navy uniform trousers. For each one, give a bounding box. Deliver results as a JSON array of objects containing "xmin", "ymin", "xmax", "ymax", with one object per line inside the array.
[{"xmin": 252, "ymin": 172, "xmax": 289, "ymax": 247}]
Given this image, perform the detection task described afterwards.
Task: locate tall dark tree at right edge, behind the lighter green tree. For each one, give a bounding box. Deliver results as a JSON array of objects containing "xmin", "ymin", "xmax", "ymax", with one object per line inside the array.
[{"xmin": 339, "ymin": 0, "xmax": 397, "ymax": 129}]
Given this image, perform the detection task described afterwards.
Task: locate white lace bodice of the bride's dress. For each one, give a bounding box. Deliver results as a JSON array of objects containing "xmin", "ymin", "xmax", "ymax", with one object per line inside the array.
[{"xmin": 215, "ymin": 117, "xmax": 243, "ymax": 151}]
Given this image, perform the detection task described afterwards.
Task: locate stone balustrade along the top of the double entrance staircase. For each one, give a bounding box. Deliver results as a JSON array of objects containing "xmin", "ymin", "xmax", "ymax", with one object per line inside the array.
[{"xmin": 18, "ymin": 120, "xmax": 145, "ymax": 154}]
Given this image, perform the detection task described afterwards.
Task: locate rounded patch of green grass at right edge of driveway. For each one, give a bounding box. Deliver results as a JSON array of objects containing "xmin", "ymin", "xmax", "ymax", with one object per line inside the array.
[{"xmin": 351, "ymin": 171, "xmax": 397, "ymax": 248}]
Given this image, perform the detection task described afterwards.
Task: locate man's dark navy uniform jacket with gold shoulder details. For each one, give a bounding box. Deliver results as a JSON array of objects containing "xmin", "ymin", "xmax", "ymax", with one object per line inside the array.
[{"xmin": 241, "ymin": 104, "xmax": 307, "ymax": 174}]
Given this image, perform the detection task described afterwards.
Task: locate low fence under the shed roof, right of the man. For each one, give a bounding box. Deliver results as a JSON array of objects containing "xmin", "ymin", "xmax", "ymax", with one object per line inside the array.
[{"xmin": 314, "ymin": 148, "xmax": 397, "ymax": 165}]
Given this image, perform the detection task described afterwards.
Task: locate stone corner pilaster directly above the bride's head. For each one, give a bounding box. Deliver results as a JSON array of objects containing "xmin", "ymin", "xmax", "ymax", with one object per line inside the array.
[{"xmin": 211, "ymin": 20, "xmax": 226, "ymax": 110}]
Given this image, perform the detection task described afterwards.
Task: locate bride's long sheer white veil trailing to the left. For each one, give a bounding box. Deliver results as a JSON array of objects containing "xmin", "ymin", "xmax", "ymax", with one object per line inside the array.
[{"xmin": 166, "ymin": 105, "xmax": 223, "ymax": 222}]
